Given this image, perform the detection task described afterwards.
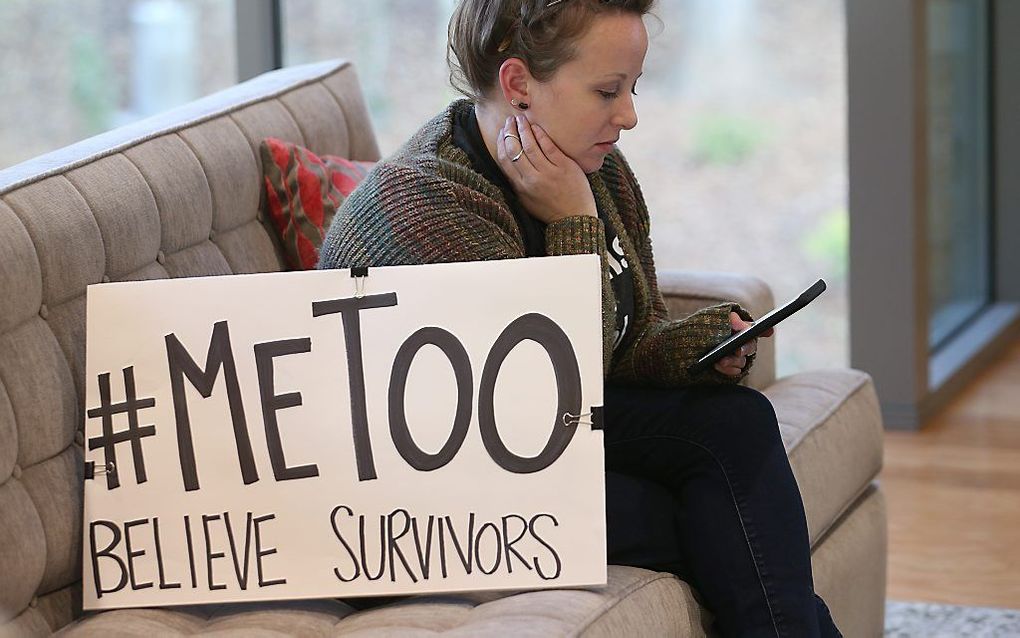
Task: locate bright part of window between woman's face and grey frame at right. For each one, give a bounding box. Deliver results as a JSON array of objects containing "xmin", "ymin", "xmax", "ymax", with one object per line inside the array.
[{"xmin": 632, "ymin": 0, "xmax": 850, "ymax": 374}]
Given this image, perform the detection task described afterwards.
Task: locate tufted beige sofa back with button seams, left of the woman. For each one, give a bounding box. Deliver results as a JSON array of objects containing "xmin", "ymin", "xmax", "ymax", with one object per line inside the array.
[{"xmin": 0, "ymin": 60, "xmax": 378, "ymax": 636}]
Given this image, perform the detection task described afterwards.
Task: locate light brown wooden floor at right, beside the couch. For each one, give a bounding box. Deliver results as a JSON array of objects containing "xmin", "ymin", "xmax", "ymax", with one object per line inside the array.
[{"xmin": 881, "ymin": 332, "xmax": 1020, "ymax": 608}]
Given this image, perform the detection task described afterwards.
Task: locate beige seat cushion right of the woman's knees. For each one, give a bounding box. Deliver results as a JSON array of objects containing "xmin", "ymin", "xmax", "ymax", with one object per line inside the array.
[{"xmin": 765, "ymin": 369, "xmax": 882, "ymax": 546}]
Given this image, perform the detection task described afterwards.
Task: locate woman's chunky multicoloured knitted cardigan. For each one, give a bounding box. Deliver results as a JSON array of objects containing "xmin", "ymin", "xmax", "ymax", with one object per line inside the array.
[{"xmin": 318, "ymin": 100, "xmax": 751, "ymax": 387}]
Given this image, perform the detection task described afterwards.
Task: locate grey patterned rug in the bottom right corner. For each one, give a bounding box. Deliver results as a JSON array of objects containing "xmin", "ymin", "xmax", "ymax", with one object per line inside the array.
[{"xmin": 885, "ymin": 600, "xmax": 1020, "ymax": 638}]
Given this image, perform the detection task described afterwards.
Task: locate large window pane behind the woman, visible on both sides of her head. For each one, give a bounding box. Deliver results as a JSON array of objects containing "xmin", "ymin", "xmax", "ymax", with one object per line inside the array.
[{"xmin": 284, "ymin": 0, "xmax": 849, "ymax": 374}]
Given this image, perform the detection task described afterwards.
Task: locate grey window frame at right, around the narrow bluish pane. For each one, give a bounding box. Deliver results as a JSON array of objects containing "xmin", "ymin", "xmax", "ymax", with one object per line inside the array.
[{"xmin": 846, "ymin": 0, "xmax": 1020, "ymax": 430}]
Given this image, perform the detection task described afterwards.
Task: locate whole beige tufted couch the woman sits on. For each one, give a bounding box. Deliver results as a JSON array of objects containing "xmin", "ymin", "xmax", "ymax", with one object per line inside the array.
[{"xmin": 0, "ymin": 61, "xmax": 886, "ymax": 637}]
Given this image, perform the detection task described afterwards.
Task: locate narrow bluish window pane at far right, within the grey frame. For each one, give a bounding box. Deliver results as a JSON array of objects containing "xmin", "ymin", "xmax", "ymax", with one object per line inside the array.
[{"xmin": 927, "ymin": 0, "xmax": 991, "ymax": 348}]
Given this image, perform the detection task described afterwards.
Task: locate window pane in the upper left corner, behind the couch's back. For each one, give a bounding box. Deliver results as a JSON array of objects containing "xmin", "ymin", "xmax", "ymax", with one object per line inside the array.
[{"xmin": 0, "ymin": 0, "xmax": 237, "ymax": 167}]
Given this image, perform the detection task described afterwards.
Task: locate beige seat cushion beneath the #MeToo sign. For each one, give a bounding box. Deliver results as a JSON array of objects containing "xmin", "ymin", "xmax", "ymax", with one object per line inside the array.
[{"xmin": 60, "ymin": 566, "xmax": 710, "ymax": 638}]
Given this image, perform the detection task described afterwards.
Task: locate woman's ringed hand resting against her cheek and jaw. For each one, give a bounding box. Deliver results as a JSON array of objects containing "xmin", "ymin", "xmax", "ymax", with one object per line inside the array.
[{"xmin": 496, "ymin": 115, "xmax": 598, "ymax": 224}]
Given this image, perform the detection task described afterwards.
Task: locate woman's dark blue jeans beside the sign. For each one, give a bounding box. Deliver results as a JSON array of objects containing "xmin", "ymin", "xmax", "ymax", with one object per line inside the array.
[{"xmin": 605, "ymin": 385, "xmax": 840, "ymax": 638}]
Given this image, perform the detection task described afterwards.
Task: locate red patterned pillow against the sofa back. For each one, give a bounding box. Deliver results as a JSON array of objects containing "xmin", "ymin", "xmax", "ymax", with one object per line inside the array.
[{"xmin": 259, "ymin": 138, "xmax": 375, "ymax": 271}]
